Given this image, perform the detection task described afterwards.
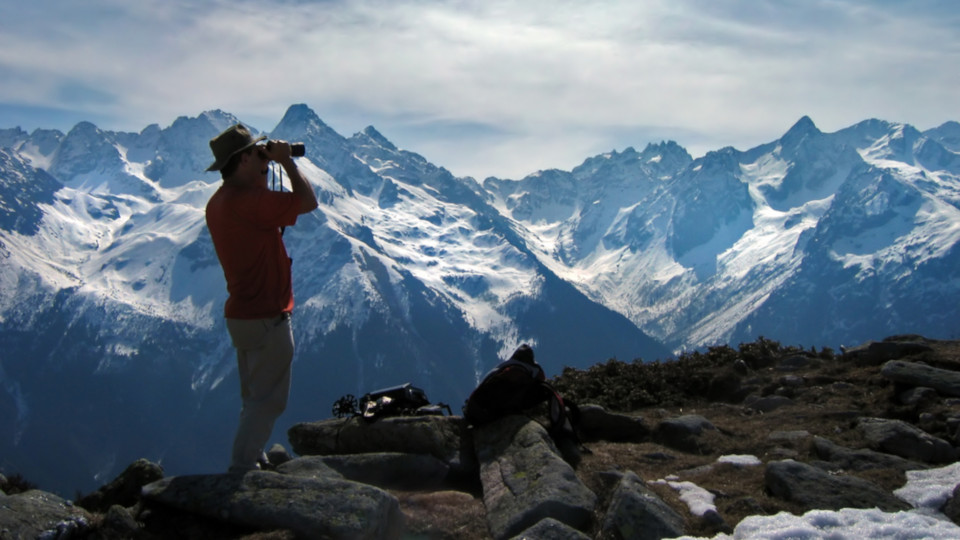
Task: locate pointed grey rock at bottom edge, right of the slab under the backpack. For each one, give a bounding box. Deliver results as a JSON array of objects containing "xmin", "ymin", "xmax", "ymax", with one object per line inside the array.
[{"xmin": 600, "ymin": 472, "xmax": 684, "ymax": 540}]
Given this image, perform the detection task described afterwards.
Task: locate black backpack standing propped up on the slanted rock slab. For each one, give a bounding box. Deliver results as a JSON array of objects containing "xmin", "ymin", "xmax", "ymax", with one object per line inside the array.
[{"xmin": 463, "ymin": 344, "xmax": 580, "ymax": 444}]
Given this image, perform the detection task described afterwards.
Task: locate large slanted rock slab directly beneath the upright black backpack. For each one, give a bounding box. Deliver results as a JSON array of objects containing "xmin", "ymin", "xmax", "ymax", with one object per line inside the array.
[{"xmin": 474, "ymin": 415, "xmax": 597, "ymax": 538}]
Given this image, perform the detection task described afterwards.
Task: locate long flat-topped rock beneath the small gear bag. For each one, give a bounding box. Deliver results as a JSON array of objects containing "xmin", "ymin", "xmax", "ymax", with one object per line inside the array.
[{"xmin": 287, "ymin": 416, "xmax": 477, "ymax": 475}]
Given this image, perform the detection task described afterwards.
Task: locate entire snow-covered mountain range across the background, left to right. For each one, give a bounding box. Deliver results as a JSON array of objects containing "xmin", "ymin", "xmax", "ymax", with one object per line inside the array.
[{"xmin": 0, "ymin": 105, "xmax": 960, "ymax": 492}]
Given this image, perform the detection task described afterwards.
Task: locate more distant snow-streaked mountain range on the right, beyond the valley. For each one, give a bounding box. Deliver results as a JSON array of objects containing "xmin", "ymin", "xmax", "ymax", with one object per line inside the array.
[{"xmin": 483, "ymin": 117, "xmax": 960, "ymax": 350}]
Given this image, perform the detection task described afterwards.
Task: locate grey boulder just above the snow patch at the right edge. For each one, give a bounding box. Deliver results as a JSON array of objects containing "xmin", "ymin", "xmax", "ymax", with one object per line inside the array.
[{"xmin": 857, "ymin": 418, "xmax": 957, "ymax": 463}]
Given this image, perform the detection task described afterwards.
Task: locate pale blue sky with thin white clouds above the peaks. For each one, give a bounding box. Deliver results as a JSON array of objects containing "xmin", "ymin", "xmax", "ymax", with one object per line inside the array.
[{"xmin": 0, "ymin": 0, "xmax": 960, "ymax": 179}]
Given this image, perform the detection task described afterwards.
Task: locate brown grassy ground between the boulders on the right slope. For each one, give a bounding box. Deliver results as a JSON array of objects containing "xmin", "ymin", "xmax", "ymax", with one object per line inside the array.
[{"xmin": 560, "ymin": 336, "xmax": 960, "ymax": 536}]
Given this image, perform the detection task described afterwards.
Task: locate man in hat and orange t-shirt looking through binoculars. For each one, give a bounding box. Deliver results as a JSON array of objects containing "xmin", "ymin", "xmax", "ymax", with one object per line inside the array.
[{"xmin": 206, "ymin": 124, "xmax": 317, "ymax": 472}]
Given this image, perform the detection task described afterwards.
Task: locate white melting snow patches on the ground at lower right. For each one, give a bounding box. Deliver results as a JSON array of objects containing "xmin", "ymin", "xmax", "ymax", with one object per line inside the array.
[{"xmin": 668, "ymin": 456, "xmax": 960, "ymax": 540}]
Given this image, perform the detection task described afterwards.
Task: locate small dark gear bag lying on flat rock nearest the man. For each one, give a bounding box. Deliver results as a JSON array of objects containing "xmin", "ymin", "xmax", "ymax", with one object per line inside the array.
[{"xmin": 333, "ymin": 383, "xmax": 450, "ymax": 422}]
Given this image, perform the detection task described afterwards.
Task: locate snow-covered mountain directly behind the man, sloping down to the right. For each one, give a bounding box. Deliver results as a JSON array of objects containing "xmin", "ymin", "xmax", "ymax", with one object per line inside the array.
[{"xmin": 0, "ymin": 106, "xmax": 669, "ymax": 493}]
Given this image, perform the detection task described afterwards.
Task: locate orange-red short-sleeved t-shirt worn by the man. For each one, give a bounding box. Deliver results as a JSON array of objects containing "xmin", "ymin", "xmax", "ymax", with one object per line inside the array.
[{"xmin": 206, "ymin": 184, "xmax": 299, "ymax": 319}]
